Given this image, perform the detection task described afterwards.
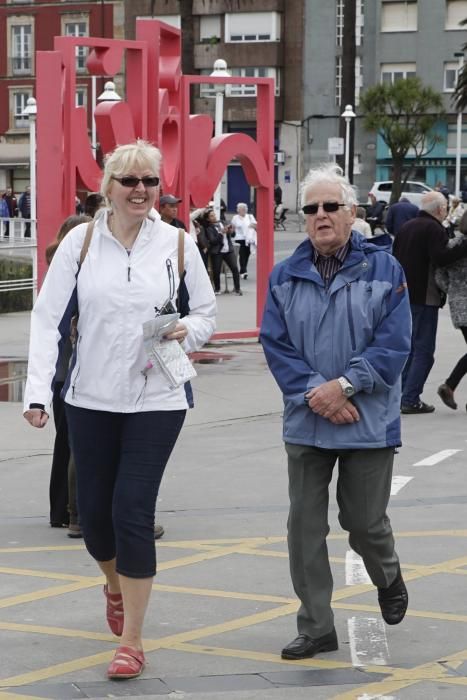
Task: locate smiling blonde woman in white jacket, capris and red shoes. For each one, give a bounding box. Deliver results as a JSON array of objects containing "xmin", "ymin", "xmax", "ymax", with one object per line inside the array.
[{"xmin": 24, "ymin": 140, "xmax": 216, "ymax": 678}]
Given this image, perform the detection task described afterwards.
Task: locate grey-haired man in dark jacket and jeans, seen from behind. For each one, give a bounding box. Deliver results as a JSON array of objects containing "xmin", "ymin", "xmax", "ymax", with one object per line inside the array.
[{"xmin": 393, "ymin": 192, "xmax": 467, "ymax": 414}]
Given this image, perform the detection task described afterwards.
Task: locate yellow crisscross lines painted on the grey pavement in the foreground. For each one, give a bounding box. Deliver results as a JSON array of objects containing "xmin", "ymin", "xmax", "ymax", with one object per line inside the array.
[{"xmin": 0, "ymin": 530, "xmax": 467, "ymax": 700}]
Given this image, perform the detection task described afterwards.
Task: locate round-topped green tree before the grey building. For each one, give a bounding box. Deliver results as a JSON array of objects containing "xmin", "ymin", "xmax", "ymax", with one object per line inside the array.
[{"xmin": 359, "ymin": 77, "xmax": 443, "ymax": 203}]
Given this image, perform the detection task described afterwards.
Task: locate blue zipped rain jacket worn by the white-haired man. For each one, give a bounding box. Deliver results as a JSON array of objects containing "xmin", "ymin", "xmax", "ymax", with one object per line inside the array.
[{"xmin": 260, "ymin": 231, "xmax": 411, "ymax": 450}]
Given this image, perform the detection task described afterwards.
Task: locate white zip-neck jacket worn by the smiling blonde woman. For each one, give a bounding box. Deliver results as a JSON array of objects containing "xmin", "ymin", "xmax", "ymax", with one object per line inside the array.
[{"xmin": 24, "ymin": 210, "xmax": 216, "ymax": 413}]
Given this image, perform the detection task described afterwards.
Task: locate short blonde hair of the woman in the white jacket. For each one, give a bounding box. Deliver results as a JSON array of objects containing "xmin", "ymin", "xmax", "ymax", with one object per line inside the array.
[{"xmin": 101, "ymin": 139, "xmax": 162, "ymax": 206}]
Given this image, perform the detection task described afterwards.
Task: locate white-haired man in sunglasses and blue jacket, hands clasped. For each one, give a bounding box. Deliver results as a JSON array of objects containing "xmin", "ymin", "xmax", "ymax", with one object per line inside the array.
[{"xmin": 260, "ymin": 164, "xmax": 410, "ymax": 659}]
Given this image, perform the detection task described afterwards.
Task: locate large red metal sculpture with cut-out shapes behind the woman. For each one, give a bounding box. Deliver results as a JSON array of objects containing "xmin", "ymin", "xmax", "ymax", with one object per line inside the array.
[{"xmin": 37, "ymin": 20, "xmax": 274, "ymax": 337}]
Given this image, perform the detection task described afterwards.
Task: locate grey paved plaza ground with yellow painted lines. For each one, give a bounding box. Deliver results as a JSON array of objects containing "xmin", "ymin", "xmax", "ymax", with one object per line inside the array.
[{"xmin": 0, "ymin": 221, "xmax": 467, "ymax": 700}]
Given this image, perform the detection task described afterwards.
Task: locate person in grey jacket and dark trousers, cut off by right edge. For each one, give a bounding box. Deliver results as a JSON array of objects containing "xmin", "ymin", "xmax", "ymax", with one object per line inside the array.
[{"xmin": 435, "ymin": 212, "xmax": 467, "ymax": 410}]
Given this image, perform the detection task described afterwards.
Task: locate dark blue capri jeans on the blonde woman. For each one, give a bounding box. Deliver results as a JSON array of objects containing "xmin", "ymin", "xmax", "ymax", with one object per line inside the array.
[{"xmin": 65, "ymin": 404, "xmax": 186, "ymax": 578}]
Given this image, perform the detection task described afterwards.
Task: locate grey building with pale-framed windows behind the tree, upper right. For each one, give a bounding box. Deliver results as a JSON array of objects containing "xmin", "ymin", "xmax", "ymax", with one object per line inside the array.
[{"xmin": 301, "ymin": 0, "xmax": 467, "ymax": 201}]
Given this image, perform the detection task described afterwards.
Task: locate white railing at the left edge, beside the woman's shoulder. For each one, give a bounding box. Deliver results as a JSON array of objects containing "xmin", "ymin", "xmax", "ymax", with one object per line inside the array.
[{"xmin": 0, "ymin": 218, "xmax": 37, "ymax": 299}]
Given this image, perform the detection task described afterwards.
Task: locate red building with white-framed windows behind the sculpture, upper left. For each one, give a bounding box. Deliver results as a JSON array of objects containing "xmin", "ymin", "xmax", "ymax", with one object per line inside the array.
[{"xmin": 0, "ymin": 0, "xmax": 124, "ymax": 192}]
